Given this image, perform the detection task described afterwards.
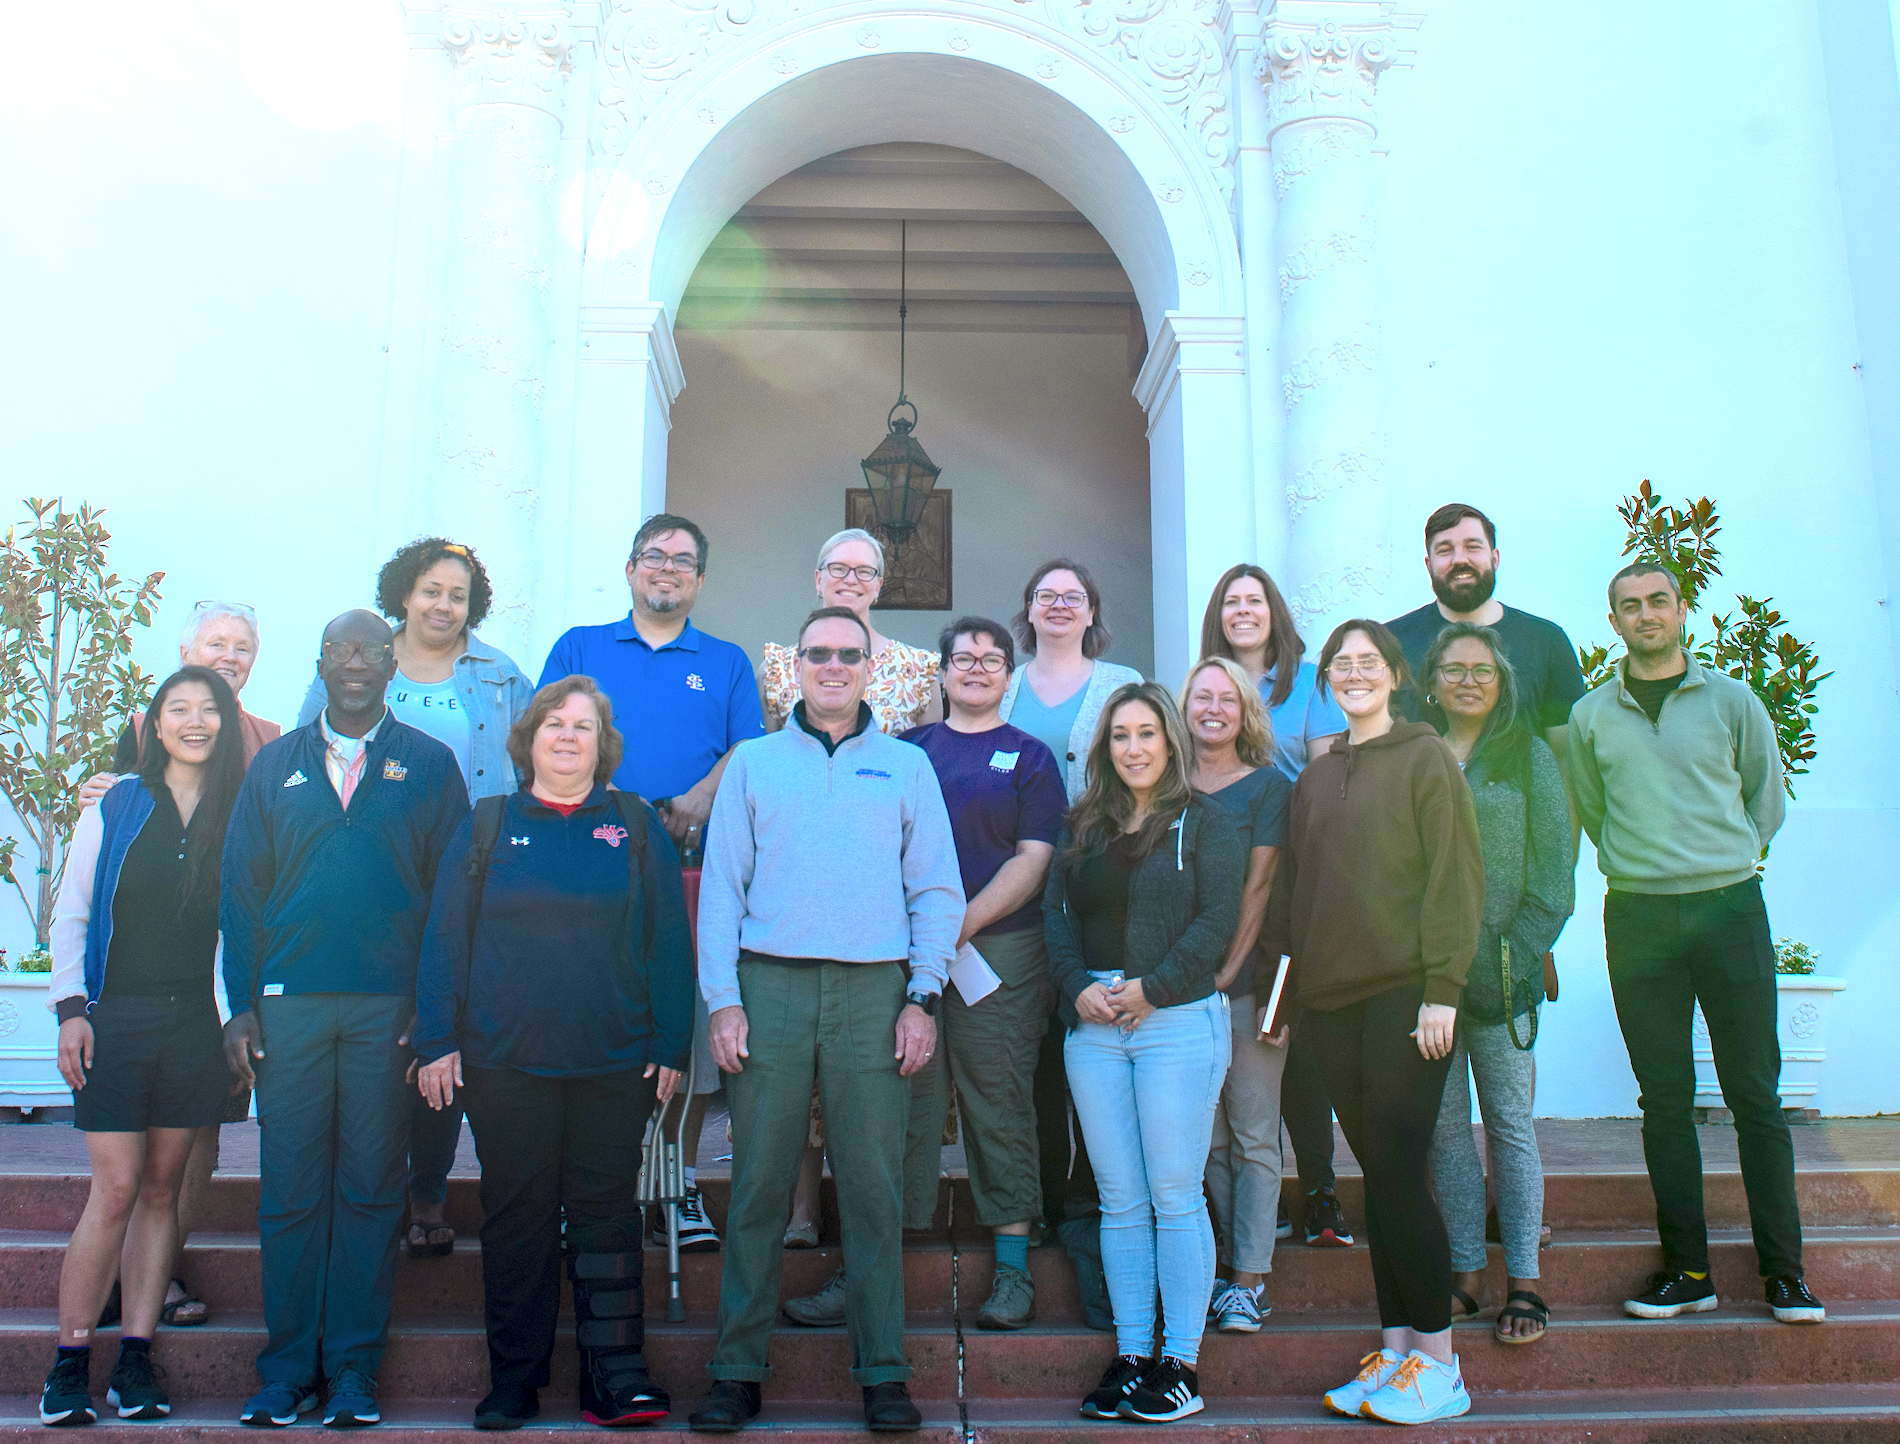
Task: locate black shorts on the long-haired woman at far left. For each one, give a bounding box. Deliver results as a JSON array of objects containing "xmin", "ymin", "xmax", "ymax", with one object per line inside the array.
[{"xmin": 72, "ymin": 996, "xmax": 232, "ymax": 1132}]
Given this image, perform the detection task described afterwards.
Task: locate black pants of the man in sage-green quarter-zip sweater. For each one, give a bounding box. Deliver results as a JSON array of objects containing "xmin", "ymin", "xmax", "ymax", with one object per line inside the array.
[{"xmin": 1604, "ymin": 878, "xmax": 1801, "ymax": 1279}]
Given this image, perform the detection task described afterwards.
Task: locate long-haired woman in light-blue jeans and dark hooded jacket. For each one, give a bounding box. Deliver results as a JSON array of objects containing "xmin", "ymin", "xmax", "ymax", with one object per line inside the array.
[{"xmin": 1043, "ymin": 682, "xmax": 1246, "ymax": 1423}]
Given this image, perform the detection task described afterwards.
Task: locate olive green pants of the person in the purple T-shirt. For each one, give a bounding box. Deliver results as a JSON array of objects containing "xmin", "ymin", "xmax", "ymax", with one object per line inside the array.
[{"xmin": 904, "ymin": 927, "xmax": 1055, "ymax": 1229}]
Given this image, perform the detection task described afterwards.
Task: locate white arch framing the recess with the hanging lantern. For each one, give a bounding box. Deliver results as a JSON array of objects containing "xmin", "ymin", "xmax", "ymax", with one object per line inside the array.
[{"xmin": 568, "ymin": 26, "xmax": 1254, "ymax": 676}]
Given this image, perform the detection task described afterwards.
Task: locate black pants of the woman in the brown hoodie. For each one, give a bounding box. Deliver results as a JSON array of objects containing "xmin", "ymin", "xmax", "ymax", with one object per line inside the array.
[{"xmin": 1296, "ymin": 982, "xmax": 1452, "ymax": 1334}]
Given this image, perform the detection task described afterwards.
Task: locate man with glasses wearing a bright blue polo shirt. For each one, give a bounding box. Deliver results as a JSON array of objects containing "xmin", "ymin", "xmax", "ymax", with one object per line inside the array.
[{"xmin": 540, "ymin": 511, "xmax": 766, "ymax": 1254}]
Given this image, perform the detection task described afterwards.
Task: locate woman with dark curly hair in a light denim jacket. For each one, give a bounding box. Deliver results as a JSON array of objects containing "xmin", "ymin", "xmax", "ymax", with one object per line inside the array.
[{"xmin": 296, "ymin": 536, "xmax": 534, "ymax": 1258}]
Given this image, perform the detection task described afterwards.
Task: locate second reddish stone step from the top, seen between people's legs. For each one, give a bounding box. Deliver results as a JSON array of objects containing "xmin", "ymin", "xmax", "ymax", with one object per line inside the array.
[{"xmin": 0, "ymin": 1227, "xmax": 1900, "ymax": 1322}]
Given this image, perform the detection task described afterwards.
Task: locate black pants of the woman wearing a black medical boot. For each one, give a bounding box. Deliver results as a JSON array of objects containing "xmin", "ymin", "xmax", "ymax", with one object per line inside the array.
[{"xmin": 464, "ymin": 1068, "xmax": 657, "ymax": 1389}]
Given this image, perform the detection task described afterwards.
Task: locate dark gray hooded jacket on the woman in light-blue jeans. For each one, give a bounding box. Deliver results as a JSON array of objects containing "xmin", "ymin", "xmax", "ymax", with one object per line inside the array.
[{"xmin": 1043, "ymin": 796, "xmax": 1246, "ymax": 1028}]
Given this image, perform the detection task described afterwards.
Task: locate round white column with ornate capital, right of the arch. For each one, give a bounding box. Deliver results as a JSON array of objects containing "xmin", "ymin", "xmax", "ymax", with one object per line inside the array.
[{"xmin": 1256, "ymin": 0, "xmax": 1419, "ymax": 648}]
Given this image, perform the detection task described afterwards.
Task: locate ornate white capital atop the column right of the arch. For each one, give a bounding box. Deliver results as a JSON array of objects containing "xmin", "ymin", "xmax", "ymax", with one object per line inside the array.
[{"xmin": 1254, "ymin": 0, "xmax": 1423, "ymax": 133}]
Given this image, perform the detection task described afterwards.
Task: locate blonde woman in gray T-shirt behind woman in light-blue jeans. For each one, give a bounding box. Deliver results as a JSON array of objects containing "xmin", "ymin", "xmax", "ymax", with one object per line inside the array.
[{"xmin": 1182, "ymin": 657, "xmax": 1294, "ymax": 1334}]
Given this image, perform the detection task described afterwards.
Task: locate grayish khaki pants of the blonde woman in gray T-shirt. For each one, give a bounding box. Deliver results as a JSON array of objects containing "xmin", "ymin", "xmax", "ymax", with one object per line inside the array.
[{"xmin": 1207, "ymin": 994, "xmax": 1286, "ymax": 1273}]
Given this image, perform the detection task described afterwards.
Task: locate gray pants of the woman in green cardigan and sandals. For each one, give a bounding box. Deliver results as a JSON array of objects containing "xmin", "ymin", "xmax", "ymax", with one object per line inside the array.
[{"xmin": 1431, "ymin": 1015, "xmax": 1543, "ymax": 1279}]
